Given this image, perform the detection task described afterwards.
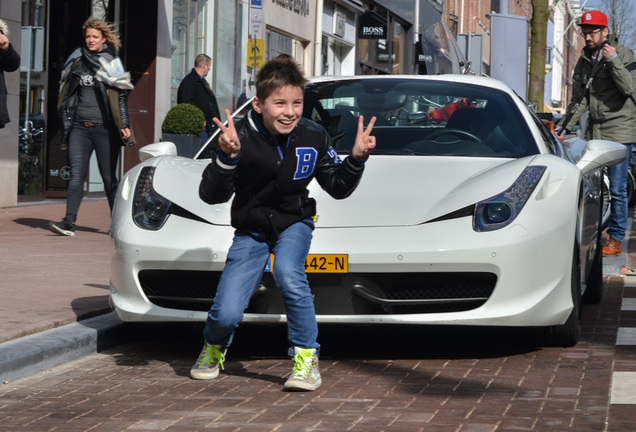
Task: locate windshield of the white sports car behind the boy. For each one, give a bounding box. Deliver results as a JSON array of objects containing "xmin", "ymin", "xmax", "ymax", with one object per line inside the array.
[{"xmin": 200, "ymin": 78, "xmax": 539, "ymax": 158}]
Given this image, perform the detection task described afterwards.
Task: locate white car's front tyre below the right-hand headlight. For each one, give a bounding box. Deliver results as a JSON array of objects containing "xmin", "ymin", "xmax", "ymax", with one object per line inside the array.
[{"xmin": 543, "ymin": 246, "xmax": 581, "ymax": 348}]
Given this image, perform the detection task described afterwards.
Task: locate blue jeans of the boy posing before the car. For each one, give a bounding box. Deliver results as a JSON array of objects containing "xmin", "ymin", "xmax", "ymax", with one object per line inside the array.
[{"xmin": 203, "ymin": 222, "xmax": 320, "ymax": 352}]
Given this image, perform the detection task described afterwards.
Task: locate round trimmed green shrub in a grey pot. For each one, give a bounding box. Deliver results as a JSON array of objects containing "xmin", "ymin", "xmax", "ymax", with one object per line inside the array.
[{"xmin": 161, "ymin": 103, "xmax": 205, "ymax": 158}]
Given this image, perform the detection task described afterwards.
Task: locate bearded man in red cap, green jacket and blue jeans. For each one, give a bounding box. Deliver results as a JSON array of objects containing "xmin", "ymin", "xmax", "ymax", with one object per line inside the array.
[{"xmin": 560, "ymin": 10, "xmax": 636, "ymax": 256}]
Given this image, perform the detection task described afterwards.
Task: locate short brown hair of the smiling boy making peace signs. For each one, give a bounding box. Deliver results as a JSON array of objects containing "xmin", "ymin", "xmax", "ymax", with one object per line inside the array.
[{"xmin": 256, "ymin": 54, "xmax": 307, "ymax": 101}]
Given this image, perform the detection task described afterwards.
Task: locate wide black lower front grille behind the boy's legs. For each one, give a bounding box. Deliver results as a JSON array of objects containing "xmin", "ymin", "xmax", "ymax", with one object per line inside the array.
[{"xmin": 139, "ymin": 270, "xmax": 497, "ymax": 315}]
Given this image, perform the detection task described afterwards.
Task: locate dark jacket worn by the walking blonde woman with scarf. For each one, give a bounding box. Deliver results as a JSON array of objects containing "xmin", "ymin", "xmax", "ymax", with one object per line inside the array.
[{"xmin": 57, "ymin": 45, "xmax": 134, "ymax": 148}]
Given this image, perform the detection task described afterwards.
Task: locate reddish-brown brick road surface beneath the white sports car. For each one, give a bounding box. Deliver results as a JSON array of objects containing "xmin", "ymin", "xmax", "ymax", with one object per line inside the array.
[{"xmin": 0, "ymin": 277, "xmax": 636, "ymax": 432}]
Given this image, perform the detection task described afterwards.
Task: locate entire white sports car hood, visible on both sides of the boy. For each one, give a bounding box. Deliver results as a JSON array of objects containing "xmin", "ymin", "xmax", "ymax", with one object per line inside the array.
[{"xmin": 153, "ymin": 155, "xmax": 533, "ymax": 228}]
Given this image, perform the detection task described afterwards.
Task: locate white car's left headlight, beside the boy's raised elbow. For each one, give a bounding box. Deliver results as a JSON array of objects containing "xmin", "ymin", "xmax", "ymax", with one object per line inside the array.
[{"xmin": 132, "ymin": 167, "xmax": 172, "ymax": 231}]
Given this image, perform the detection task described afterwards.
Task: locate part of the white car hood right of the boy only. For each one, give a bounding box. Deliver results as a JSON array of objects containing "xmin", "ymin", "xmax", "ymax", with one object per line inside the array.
[{"xmin": 310, "ymin": 156, "xmax": 532, "ymax": 227}]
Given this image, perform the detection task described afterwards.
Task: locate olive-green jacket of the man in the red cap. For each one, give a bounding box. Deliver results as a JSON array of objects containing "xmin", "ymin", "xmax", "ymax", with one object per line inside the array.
[{"xmin": 563, "ymin": 35, "xmax": 636, "ymax": 144}]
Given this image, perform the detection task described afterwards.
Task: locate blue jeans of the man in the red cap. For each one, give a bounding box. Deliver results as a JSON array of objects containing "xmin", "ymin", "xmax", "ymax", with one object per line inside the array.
[{"xmin": 607, "ymin": 144, "xmax": 634, "ymax": 242}]
